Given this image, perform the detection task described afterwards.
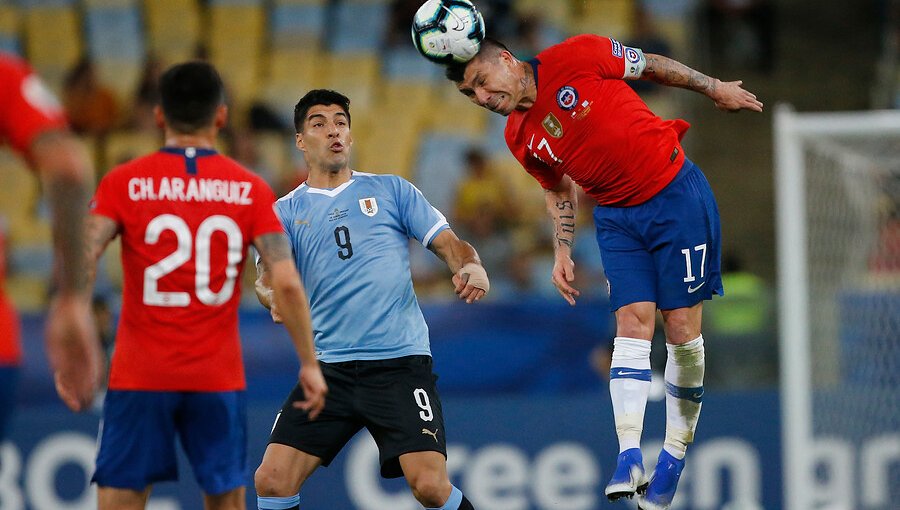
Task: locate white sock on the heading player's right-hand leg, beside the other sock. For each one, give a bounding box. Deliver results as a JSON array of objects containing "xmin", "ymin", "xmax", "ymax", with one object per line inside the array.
[{"xmin": 663, "ymin": 335, "xmax": 706, "ymax": 459}]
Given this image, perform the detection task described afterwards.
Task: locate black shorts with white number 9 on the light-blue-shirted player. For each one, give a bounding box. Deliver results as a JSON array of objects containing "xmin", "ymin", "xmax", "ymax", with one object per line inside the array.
[{"xmin": 269, "ymin": 356, "xmax": 447, "ymax": 478}]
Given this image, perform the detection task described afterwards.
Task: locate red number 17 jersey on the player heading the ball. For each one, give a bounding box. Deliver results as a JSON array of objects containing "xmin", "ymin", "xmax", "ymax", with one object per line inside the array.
[{"xmin": 506, "ymin": 35, "xmax": 690, "ymax": 207}]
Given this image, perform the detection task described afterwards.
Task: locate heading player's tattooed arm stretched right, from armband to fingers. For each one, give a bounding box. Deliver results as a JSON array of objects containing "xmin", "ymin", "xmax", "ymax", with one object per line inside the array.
[{"xmin": 641, "ymin": 53, "xmax": 763, "ymax": 112}]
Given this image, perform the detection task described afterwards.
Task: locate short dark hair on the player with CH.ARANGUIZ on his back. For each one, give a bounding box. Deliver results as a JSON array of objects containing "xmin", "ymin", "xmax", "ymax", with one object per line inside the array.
[{"xmin": 159, "ymin": 61, "xmax": 225, "ymax": 133}]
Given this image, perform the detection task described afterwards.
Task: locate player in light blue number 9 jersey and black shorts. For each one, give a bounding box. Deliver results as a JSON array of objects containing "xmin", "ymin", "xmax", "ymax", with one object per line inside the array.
[{"xmin": 255, "ymin": 90, "xmax": 490, "ymax": 510}]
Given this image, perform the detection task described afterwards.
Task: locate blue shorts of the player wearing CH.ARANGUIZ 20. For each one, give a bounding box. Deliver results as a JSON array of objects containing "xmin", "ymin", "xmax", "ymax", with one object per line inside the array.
[{"xmin": 91, "ymin": 390, "xmax": 248, "ymax": 494}]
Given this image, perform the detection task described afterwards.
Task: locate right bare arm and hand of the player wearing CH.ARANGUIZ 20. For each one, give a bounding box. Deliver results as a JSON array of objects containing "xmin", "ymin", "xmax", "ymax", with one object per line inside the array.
[{"xmin": 253, "ymin": 234, "xmax": 328, "ymax": 419}]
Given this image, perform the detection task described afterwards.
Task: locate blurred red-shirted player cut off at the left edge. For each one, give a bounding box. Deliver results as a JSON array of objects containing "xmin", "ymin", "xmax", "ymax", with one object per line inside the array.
[{"xmin": 0, "ymin": 53, "xmax": 103, "ymax": 430}]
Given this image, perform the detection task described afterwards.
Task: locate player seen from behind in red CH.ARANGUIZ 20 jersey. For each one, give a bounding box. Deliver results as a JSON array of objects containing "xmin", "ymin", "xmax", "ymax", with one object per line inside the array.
[{"xmin": 87, "ymin": 62, "xmax": 327, "ymax": 510}]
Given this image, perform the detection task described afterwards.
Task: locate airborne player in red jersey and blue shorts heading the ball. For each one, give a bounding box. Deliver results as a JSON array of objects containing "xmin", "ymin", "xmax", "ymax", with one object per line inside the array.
[{"xmin": 446, "ymin": 35, "xmax": 763, "ymax": 510}]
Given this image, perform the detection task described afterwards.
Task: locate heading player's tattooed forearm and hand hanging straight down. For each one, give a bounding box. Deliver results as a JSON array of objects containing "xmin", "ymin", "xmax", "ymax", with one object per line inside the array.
[{"xmin": 544, "ymin": 177, "xmax": 581, "ymax": 306}]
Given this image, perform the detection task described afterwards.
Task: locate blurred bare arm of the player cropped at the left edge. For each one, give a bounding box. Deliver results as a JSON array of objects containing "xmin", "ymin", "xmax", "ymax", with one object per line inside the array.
[{"xmin": 36, "ymin": 131, "xmax": 103, "ymax": 411}]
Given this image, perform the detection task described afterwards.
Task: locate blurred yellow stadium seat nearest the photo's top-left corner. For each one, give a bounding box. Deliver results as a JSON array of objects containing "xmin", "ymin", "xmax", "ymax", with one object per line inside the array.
[{"xmin": 22, "ymin": 4, "xmax": 82, "ymax": 93}]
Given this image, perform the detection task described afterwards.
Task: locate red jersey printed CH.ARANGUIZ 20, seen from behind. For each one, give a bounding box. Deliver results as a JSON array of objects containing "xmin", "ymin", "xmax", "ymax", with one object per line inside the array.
[{"xmin": 91, "ymin": 147, "xmax": 283, "ymax": 391}]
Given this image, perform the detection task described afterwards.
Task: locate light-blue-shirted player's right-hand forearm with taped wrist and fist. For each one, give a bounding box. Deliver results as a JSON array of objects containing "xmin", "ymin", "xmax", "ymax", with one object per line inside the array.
[{"xmin": 428, "ymin": 228, "xmax": 491, "ymax": 303}]
